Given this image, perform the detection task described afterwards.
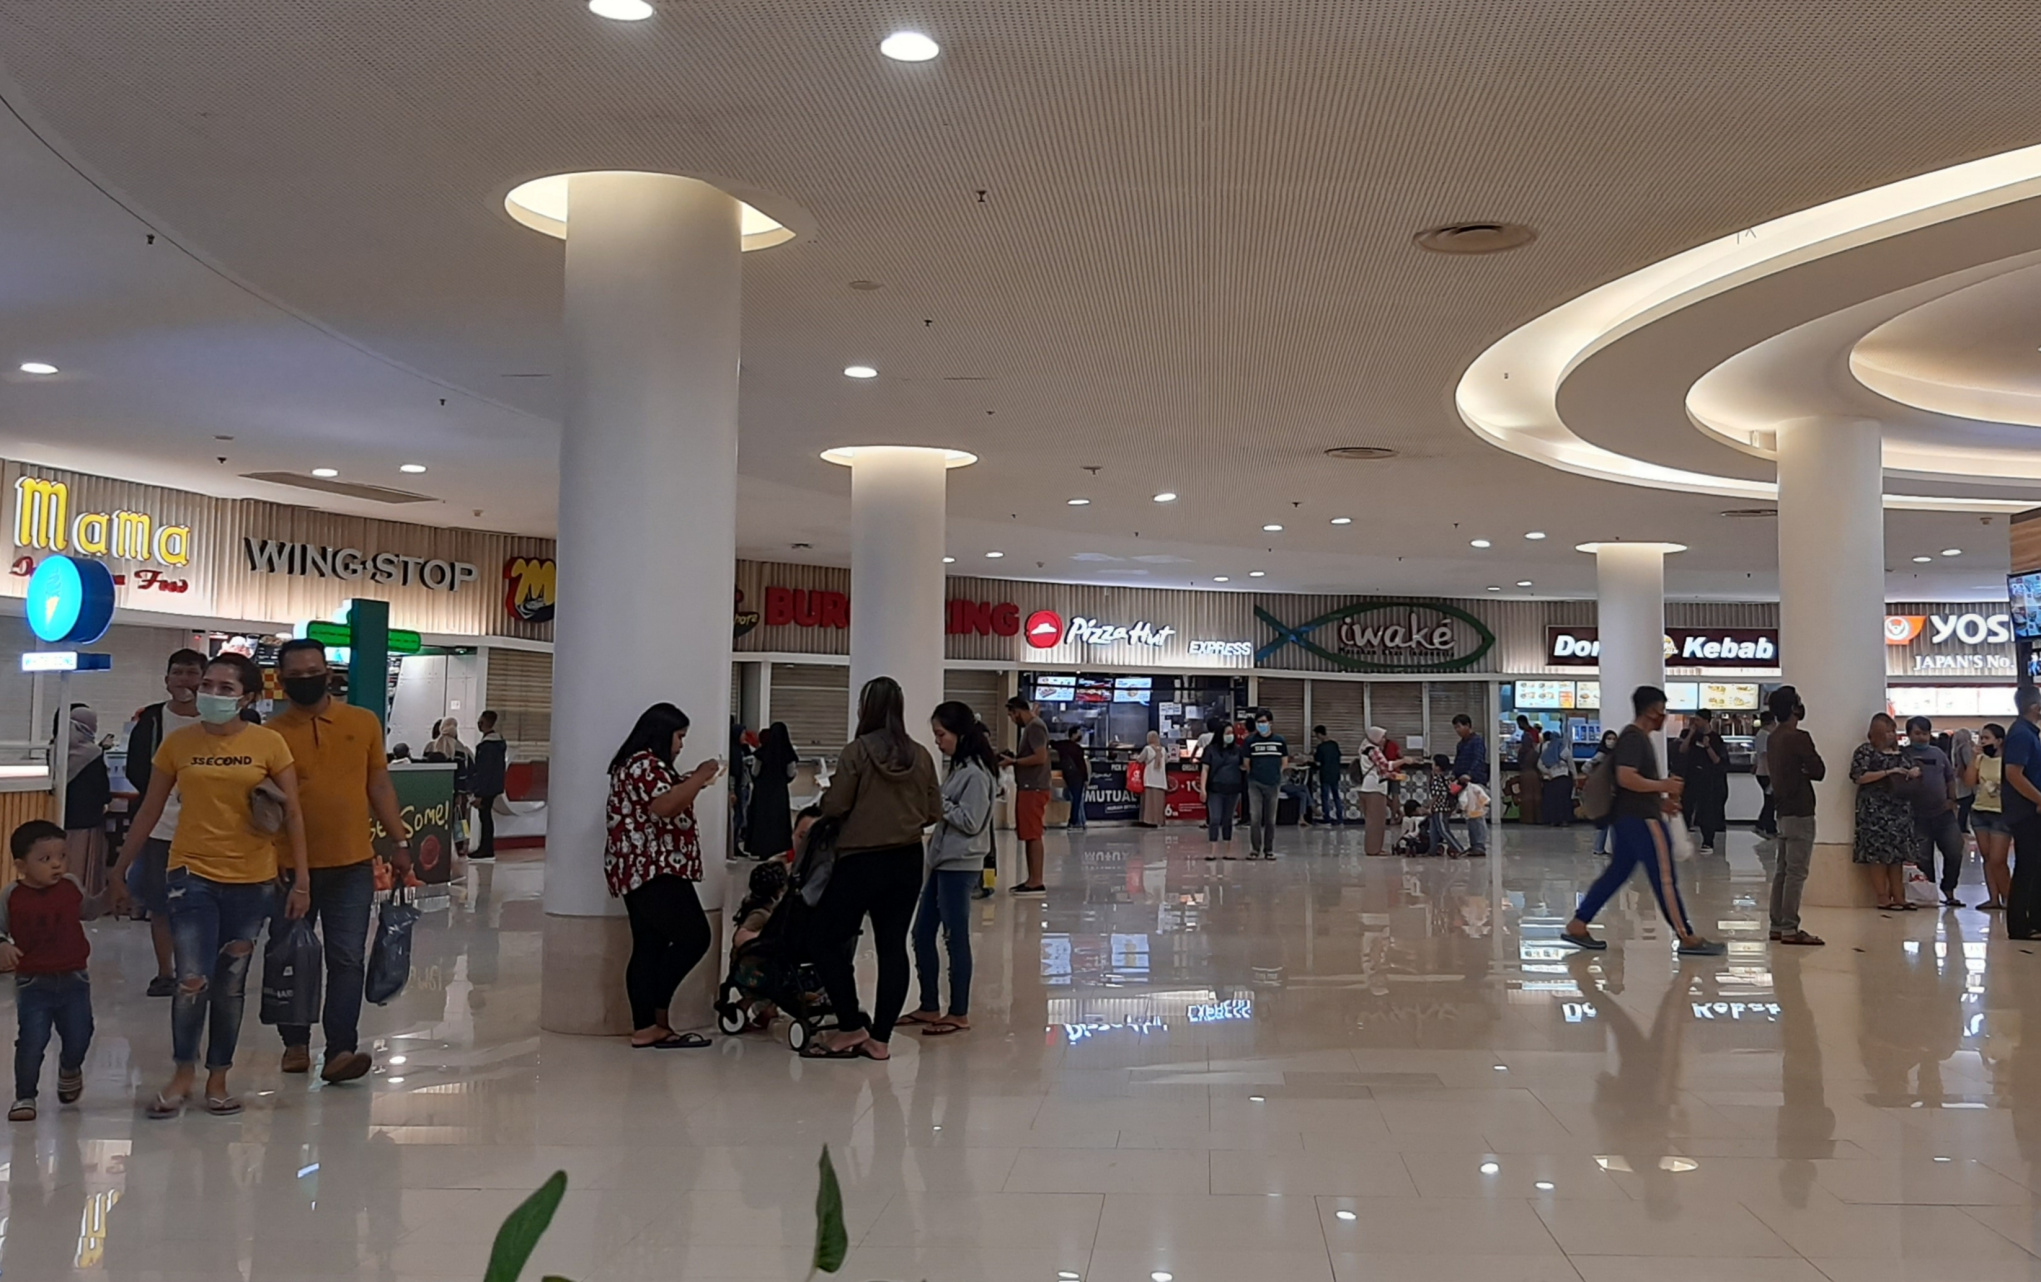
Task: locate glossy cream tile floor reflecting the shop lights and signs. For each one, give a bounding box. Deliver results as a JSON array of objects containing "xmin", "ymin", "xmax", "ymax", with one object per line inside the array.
[{"xmin": 0, "ymin": 829, "xmax": 2041, "ymax": 1282}]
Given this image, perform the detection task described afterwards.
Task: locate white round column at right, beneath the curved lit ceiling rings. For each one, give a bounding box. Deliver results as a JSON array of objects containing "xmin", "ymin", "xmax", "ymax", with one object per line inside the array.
[{"xmin": 1778, "ymin": 418, "xmax": 1886, "ymax": 906}]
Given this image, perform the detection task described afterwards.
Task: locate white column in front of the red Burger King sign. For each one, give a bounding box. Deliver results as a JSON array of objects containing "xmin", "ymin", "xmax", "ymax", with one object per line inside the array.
[{"xmin": 833, "ymin": 445, "xmax": 959, "ymax": 743}]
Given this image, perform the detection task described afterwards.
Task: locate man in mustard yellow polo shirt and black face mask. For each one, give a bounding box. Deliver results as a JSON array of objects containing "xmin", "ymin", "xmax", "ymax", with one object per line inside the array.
[{"xmin": 269, "ymin": 637, "xmax": 410, "ymax": 1082}]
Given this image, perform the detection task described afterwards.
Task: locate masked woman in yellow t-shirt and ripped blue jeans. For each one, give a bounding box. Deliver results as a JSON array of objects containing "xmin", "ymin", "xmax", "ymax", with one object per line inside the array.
[{"xmin": 114, "ymin": 655, "xmax": 312, "ymax": 1119}]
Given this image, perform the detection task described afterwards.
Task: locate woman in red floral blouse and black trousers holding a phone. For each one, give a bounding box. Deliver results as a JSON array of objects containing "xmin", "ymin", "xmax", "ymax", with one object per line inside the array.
[{"xmin": 602, "ymin": 704, "xmax": 716, "ymax": 1051}]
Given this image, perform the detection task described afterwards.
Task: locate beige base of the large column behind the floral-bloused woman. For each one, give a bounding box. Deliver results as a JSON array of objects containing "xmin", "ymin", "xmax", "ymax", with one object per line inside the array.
[{"xmin": 539, "ymin": 910, "xmax": 723, "ymax": 1037}]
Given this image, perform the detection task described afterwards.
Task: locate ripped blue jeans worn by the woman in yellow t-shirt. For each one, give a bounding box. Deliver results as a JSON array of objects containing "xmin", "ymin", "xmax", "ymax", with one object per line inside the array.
[{"xmin": 165, "ymin": 868, "xmax": 276, "ymax": 1072}]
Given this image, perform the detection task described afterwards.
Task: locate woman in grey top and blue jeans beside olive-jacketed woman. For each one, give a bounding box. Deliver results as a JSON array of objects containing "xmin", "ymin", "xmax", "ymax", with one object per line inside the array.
[{"xmin": 900, "ymin": 700, "xmax": 1000, "ymax": 1037}]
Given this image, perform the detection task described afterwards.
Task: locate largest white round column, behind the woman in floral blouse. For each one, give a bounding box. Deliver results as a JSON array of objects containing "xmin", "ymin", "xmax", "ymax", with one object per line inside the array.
[{"xmin": 539, "ymin": 174, "xmax": 741, "ymax": 1033}]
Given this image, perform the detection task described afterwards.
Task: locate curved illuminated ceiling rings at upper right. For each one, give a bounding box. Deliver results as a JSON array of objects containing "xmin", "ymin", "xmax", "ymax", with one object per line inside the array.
[{"xmin": 1455, "ymin": 147, "xmax": 2041, "ymax": 512}]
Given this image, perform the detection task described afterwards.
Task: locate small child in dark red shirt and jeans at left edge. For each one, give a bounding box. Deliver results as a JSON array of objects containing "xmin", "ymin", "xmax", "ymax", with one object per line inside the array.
[{"xmin": 0, "ymin": 819, "xmax": 92, "ymax": 1121}]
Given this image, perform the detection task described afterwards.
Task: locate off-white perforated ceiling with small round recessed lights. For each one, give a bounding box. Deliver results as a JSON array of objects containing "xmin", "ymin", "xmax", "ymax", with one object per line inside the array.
[{"xmin": 0, "ymin": 0, "xmax": 2041, "ymax": 598}]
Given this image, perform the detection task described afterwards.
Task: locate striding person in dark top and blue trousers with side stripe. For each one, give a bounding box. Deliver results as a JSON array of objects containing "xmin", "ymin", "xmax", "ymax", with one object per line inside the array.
[{"xmin": 1561, "ymin": 686, "xmax": 1727, "ymax": 957}]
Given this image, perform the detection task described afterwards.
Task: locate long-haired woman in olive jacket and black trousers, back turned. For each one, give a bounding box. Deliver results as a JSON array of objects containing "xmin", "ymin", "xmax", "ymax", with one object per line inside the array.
[{"xmin": 802, "ymin": 676, "xmax": 943, "ymax": 1059}]
